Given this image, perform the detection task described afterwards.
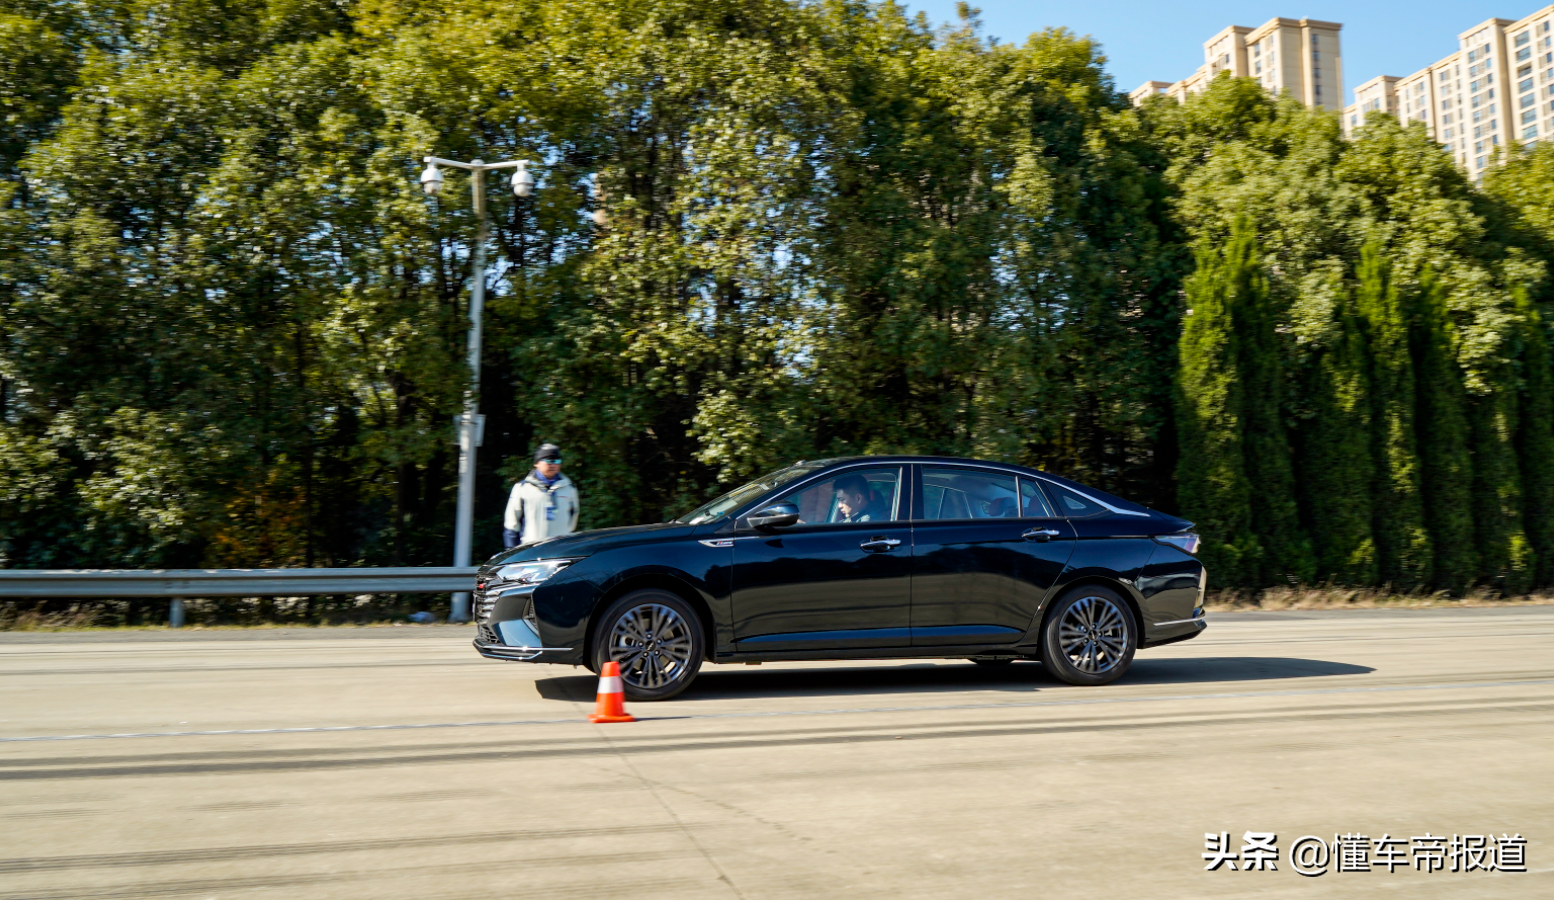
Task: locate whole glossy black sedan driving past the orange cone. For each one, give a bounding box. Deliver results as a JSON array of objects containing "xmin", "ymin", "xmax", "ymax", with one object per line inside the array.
[{"xmin": 474, "ymin": 457, "xmax": 1206, "ymax": 699}]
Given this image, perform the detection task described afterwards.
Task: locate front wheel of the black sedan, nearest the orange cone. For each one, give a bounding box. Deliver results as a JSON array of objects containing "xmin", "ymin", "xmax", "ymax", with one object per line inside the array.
[{"xmin": 592, "ymin": 588, "xmax": 707, "ymax": 699}]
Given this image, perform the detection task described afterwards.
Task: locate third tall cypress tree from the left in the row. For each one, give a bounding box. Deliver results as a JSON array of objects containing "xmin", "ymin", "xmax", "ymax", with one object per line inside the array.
[{"xmin": 1301, "ymin": 265, "xmax": 1377, "ymax": 584}]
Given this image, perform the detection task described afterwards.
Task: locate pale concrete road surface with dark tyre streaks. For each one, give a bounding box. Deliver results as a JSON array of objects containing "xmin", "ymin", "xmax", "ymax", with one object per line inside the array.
[{"xmin": 0, "ymin": 606, "xmax": 1554, "ymax": 900}]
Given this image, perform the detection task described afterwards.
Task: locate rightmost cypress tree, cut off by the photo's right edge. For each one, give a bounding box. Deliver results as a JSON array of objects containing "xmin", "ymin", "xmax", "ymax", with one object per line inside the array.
[{"xmin": 1517, "ymin": 288, "xmax": 1554, "ymax": 586}]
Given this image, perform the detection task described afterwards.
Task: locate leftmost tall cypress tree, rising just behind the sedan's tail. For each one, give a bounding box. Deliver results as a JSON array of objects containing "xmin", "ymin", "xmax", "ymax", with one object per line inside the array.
[{"xmin": 1176, "ymin": 228, "xmax": 1262, "ymax": 588}]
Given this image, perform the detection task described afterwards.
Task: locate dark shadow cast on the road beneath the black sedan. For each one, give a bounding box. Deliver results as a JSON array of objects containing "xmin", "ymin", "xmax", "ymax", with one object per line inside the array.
[{"xmin": 535, "ymin": 656, "xmax": 1375, "ymax": 703}]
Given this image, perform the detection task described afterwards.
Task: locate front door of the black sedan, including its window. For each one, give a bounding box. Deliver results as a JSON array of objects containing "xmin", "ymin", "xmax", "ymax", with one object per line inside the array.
[{"xmin": 733, "ymin": 466, "xmax": 912, "ymax": 653}]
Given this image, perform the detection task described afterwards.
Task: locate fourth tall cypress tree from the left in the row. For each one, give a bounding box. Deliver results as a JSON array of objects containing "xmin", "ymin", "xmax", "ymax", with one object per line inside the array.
[{"xmin": 1355, "ymin": 241, "xmax": 1433, "ymax": 591}]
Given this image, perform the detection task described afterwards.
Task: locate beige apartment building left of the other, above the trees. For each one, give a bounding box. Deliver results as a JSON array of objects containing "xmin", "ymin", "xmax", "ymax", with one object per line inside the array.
[{"xmin": 1128, "ymin": 19, "xmax": 1344, "ymax": 112}]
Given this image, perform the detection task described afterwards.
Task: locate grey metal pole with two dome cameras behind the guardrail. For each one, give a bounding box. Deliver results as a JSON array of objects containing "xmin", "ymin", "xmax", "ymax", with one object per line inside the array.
[{"xmin": 421, "ymin": 157, "xmax": 535, "ymax": 622}]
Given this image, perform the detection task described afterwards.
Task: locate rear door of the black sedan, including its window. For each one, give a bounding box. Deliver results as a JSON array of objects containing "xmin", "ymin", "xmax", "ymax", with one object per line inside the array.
[{"xmin": 912, "ymin": 465, "xmax": 1074, "ymax": 647}]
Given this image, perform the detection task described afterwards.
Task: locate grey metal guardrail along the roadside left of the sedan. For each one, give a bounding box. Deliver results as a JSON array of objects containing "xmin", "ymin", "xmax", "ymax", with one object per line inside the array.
[{"xmin": 0, "ymin": 566, "xmax": 476, "ymax": 600}]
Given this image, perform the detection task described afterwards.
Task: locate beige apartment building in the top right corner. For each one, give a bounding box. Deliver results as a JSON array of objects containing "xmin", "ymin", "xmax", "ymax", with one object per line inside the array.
[{"xmin": 1343, "ymin": 6, "xmax": 1554, "ymax": 177}]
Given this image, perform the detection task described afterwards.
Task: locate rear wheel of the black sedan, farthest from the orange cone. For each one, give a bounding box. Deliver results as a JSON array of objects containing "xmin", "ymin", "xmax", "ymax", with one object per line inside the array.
[{"xmin": 1041, "ymin": 584, "xmax": 1139, "ymax": 684}]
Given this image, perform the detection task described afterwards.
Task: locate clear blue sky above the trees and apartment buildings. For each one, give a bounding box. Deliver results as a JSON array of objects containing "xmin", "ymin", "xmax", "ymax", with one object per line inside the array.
[{"xmin": 900, "ymin": 0, "xmax": 1549, "ymax": 104}]
